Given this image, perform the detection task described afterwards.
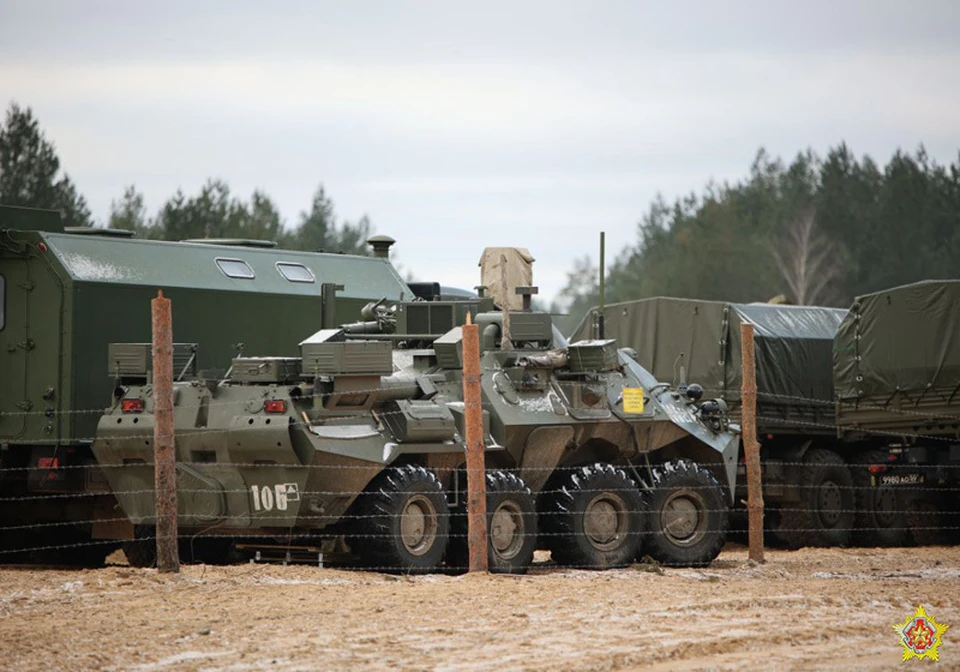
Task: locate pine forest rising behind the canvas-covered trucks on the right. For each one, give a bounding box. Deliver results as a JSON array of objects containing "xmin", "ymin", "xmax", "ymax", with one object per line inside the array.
[{"xmin": 553, "ymin": 143, "xmax": 960, "ymax": 325}]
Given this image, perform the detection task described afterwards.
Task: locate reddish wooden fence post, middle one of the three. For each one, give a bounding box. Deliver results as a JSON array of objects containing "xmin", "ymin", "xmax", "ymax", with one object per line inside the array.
[{"xmin": 463, "ymin": 313, "xmax": 488, "ymax": 572}]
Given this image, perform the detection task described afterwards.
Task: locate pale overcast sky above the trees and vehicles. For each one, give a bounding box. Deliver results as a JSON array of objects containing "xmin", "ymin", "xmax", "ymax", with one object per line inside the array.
[{"xmin": 0, "ymin": 0, "xmax": 960, "ymax": 298}]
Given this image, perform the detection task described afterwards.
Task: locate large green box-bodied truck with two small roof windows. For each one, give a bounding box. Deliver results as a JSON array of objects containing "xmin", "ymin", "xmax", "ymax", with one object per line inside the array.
[{"xmin": 0, "ymin": 206, "xmax": 413, "ymax": 559}]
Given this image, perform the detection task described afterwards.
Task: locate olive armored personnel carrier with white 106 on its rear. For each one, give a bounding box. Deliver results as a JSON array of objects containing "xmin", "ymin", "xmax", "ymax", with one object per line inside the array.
[{"xmin": 93, "ymin": 329, "xmax": 536, "ymax": 572}]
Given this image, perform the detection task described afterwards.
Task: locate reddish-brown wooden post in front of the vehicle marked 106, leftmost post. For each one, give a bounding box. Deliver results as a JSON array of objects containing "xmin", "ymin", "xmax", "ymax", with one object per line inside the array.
[{"xmin": 150, "ymin": 290, "xmax": 180, "ymax": 572}]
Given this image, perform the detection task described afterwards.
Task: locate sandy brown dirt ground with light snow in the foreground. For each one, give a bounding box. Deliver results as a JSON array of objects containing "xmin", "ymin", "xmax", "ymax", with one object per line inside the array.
[{"xmin": 0, "ymin": 546, "xmax": 960, "ymax": 670}]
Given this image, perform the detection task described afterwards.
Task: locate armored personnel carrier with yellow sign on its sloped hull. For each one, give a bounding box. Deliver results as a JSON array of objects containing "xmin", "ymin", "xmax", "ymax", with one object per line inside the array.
[{"xmin": 400, "ymin": 288, "xmax": 739, "ymax": 568}]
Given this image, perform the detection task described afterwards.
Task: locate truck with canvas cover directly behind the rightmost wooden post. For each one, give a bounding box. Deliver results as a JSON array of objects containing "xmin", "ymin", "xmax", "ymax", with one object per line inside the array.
[{"xmin": 574, "ymin": 297, "xmax": 855, "ymax": 546}]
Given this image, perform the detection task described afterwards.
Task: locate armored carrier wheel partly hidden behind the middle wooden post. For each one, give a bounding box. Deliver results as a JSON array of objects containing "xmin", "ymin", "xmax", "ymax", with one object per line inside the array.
[{"xmin": 447, "ymin": 471, "xmax": 537, "ymax": 574}]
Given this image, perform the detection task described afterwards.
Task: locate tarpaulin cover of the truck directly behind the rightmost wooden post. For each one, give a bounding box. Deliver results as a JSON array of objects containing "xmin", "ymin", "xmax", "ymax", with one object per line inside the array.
[{"xmin": 571, "ymin": 298, "xmax": 847, "ymax": 431}]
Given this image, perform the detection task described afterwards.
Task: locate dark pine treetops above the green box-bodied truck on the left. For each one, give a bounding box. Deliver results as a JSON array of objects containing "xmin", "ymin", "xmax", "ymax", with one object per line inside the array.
[{"xmin": 0, "ymin": 103, "xmax": 373, "ymax": 254}]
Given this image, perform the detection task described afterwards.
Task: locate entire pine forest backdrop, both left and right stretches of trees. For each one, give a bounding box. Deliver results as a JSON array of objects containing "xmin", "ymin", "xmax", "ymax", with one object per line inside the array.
[{"xmin": 0, "ymin": 102, "xmax": 960, "ymax": 331}]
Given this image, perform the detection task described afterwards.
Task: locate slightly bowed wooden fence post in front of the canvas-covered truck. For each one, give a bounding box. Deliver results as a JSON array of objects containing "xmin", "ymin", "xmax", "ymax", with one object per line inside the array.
[{"xmin": 740, "ymin": 322, "xmax": 764, "ymax": 562}]
